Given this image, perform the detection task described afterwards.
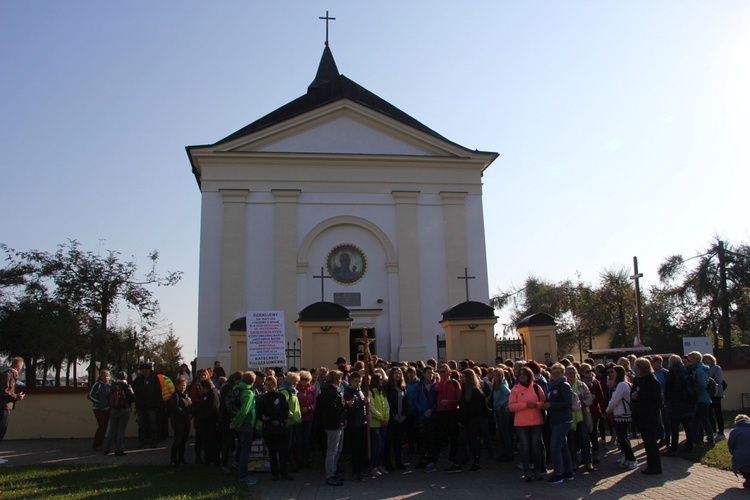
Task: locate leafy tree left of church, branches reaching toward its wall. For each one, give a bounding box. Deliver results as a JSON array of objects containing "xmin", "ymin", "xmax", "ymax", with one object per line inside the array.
[{"xmin": 3, "ymin": 240, "xmax": 182, "ymax": 379}]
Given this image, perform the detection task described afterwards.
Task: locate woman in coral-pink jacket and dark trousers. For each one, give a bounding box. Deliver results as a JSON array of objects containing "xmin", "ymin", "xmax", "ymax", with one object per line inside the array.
[{"xmin": 508, "ymin": 367, "xmax": 545, "ymax": 483}]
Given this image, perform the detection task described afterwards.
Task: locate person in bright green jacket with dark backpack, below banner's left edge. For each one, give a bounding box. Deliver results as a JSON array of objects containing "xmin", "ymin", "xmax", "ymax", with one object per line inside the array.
[{"xmin": 227, "ymin": 371, "xmax": 258, "ymax": 484}]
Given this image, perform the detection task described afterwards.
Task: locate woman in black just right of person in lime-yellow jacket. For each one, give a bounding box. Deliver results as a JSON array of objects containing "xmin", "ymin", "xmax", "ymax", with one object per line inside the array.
[{"xmin": 383, "ymin": 366, "xmax": 409, "ymax": 471}]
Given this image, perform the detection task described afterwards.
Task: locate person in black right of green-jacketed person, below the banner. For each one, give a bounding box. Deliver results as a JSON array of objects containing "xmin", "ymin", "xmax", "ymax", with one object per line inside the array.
[{"xmin": 255, "ymin": 376, "xmax": 292, "ymax": 481}]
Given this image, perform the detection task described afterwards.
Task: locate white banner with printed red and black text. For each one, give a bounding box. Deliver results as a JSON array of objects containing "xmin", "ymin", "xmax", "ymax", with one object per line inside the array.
[{"xmin": 246, "ymin": 311, "xmax": 286, "ymax": 368}]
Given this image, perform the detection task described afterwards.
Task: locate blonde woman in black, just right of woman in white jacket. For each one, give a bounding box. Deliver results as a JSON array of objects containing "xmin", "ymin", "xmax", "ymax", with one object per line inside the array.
[{"xmin": 630, "ymin": 358, "xmax": 662, "ymax": 474}]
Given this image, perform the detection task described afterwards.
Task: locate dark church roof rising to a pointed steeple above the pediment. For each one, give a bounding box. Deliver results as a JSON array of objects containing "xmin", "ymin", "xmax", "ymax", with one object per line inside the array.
[{"xmin": 214, "ymin": 46, "xmax": 458, "ymax": 147}]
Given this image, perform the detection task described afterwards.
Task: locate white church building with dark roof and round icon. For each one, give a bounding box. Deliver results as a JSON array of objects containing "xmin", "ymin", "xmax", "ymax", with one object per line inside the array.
[{"xmin": 187, "ymin": 45, "xmax": 497, "ymax": 370}]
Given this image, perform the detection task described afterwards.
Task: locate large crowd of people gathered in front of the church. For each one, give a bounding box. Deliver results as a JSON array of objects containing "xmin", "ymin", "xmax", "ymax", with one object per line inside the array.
[{"xmin": 78, "ymin": 352, "xmax": 750, "ymax": 486}]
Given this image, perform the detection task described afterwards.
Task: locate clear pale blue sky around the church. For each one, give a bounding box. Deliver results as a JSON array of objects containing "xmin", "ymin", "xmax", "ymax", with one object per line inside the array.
[{"xmin": 0, "ymin": 0, "xmax": 750, "ymax": 359}]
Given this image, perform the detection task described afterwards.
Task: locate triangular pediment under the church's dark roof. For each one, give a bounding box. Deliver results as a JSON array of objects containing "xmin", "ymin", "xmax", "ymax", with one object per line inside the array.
[{"xmin": 216, "ymin": 99, "xmax": 467, "ymax": 156}]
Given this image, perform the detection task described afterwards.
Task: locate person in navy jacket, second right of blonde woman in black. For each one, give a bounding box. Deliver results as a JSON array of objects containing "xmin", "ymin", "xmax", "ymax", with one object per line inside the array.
[{"xmin": 662, "ymin": 354, "xmax": 696, "ymax": 457}]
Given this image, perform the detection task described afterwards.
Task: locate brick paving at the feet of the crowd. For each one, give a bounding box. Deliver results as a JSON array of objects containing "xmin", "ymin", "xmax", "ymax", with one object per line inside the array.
[{"xmin": 0, "ymin": 439, "xmax": 750, "ymax": 500}]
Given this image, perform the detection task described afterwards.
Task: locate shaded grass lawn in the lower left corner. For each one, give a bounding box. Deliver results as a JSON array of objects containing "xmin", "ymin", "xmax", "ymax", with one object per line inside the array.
[{"xmin": 0, "ymin": 465, "xmax": 250, "ymax": 500}]
